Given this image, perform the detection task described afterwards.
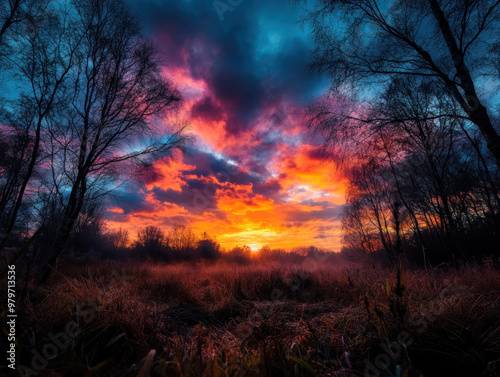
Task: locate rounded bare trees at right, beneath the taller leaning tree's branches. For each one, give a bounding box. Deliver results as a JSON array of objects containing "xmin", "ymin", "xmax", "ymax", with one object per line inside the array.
[{"xmin": 336, "ymin": 74, "xmax": 500, "ymax": 259}]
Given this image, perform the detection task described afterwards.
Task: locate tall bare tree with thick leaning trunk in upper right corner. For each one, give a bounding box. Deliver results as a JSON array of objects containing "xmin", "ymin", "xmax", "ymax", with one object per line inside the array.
[{"xmin": 298, "ymin": 0, "xmax": 500, "ymax": 166}]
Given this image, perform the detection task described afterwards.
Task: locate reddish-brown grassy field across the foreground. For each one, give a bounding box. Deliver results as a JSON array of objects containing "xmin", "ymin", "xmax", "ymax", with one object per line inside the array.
[{"xmin": 0, "ymin": 262, "xmax": 500, "ymax": 377}]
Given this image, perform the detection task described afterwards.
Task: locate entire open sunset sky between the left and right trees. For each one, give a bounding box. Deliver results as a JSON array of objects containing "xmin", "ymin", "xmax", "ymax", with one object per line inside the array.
[{"xmin": 106, "ymin": 0, "xmax": 346, "ymax": 251}]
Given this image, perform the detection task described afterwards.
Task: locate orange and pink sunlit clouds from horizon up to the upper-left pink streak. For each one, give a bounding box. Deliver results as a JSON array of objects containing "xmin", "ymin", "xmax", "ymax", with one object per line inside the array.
[{"xmin": 107, "ymin": 68, "xmax": 346, "ymax": 252}]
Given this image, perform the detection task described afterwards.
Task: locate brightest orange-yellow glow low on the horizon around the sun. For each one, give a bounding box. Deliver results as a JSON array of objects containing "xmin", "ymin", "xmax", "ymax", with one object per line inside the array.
[{"xmin": 108, "ymin": 148, "xmax": 346, "ymax": 251}]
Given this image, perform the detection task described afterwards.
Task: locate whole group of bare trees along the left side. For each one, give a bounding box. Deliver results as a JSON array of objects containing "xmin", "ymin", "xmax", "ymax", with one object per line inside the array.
[{"xmin": 0, "ymin": 0, "xmax": 186, "ymax": 280}]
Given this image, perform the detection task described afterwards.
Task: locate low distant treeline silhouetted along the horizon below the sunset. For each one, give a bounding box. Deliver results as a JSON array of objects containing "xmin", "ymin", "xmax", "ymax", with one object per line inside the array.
[{"xmin": 63, "ymin": 224, "xmax": 343, "ymax": 268}]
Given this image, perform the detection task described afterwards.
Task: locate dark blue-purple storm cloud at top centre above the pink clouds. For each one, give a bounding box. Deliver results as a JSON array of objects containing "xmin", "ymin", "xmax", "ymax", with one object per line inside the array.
[{"xmin": 129, "ymin": 0, "xmax": 326, "ymax": 135}]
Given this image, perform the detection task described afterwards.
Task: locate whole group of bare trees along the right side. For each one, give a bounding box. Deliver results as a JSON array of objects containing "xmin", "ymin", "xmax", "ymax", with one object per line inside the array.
[{"xmin": 300, "ymin": 0, "xmax": 500, "ymax": 263}]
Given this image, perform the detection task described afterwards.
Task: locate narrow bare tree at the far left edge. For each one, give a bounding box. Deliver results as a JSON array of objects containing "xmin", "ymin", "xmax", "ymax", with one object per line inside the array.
[{"xmin": 0, "ymin": 5, "xmax": 81, "ymax": 249}]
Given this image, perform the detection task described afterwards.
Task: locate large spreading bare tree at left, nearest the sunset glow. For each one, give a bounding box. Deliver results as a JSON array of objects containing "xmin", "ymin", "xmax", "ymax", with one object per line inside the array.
[{"xmin": 37, "ymin": 0, "xmax": 187, "ymax": 280}]
